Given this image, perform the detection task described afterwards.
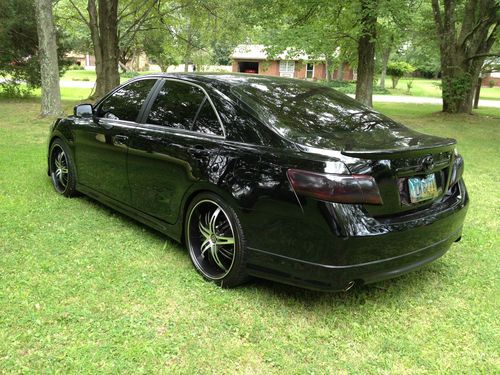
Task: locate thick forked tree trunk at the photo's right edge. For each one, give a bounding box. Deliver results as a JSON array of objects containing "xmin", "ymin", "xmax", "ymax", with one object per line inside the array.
[{"xmin": 432, "ymin": 0, "xmax": 500, "ymax": 113}]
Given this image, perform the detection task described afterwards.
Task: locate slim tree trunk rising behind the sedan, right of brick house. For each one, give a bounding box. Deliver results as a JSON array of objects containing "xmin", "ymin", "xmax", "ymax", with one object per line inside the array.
[{"xmin": 356, "ymin": 0, "xmax": 378, "ymax": 107}]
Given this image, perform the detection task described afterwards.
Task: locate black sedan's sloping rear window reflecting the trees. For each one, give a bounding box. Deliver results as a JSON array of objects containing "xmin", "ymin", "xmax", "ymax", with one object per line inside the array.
[{"xmin": 232, "ymin": 77, "xmax": 399, "ymax": 141}]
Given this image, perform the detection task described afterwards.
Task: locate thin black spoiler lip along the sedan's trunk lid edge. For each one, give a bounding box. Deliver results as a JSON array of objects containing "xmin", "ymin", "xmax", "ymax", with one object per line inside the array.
[{"xmin": 341, "ymin": 138, "xmax": 457, "ymax": 159}]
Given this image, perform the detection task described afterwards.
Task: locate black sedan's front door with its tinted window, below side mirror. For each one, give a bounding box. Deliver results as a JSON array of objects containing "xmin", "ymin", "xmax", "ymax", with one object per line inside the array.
[{"xmin": 74, "ymin": 79, "xmax": 157, "ymax": 203}]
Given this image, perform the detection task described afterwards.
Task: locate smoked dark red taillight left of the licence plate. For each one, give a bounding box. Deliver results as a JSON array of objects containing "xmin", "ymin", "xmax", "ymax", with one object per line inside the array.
[{"xmin": 287, "ymin": 169, "xmax": 382, "ymax": 204}]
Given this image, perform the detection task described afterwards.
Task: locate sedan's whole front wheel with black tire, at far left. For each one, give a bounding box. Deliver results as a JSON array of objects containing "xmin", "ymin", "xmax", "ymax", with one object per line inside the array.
[{"xmin": 49, "ymin": 139, "xmax": 78, "ymax": 197}]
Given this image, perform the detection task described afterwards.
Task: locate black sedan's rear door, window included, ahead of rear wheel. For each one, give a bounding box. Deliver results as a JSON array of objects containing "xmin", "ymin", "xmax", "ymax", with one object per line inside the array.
[{"xmin": 128, "ymin": 79, "xmax": 224, "ymax": 223}]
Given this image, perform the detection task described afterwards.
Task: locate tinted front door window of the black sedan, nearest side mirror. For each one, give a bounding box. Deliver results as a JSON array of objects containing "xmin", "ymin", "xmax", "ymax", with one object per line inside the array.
[{"xmin": 97, "ymin": 79, "xmax": 156, "ymax": 121}]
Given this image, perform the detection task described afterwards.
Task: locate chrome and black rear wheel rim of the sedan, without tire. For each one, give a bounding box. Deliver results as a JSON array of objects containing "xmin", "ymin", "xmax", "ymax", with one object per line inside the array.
[{"xmin": 187, "ymin": 199, "xmax": 236, "ymax": 280}]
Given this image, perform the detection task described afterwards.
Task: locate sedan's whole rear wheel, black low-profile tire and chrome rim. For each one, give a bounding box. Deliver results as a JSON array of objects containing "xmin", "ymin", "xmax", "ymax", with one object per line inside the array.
[{"xmin": 184, "ymin": 192, "xmax": 248, "ymax": 288}]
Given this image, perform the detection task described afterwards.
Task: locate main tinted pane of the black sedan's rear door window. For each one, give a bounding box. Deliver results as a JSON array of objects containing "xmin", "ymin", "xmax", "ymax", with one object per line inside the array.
[{"xmin": 147, "ymin": 81, "xmax": 205, "ymax": 130}]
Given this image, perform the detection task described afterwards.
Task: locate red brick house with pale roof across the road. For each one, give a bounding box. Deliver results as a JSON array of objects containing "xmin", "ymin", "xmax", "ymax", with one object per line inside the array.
[{"xmin": 230, "ymin": 44, "xmax": 355, "ymax": 80}]
